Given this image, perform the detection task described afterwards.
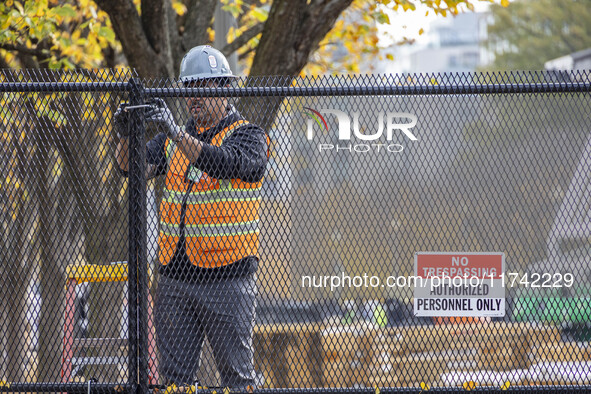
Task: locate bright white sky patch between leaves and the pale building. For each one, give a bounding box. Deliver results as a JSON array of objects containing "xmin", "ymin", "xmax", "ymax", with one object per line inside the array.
[{"xmin": 380, "ymin": 0, "xmax": 498, "ymax": 73}]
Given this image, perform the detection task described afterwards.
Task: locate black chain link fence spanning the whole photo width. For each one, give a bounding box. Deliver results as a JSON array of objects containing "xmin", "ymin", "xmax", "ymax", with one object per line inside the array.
[{"xmin": 0, "ymin": 70, "xmax": 591, "ymax": 393}]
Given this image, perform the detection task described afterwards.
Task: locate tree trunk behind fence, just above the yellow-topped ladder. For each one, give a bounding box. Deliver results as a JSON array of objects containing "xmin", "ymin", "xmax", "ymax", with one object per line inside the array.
[{"xmin": 55, "ymin": 93, "xmax": 128, "ymax": 381}]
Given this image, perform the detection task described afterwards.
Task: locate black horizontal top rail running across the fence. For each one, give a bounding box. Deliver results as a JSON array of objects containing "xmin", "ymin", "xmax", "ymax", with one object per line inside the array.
[{"xmin": 0, "ymin": 80, "xmax": 591, "ymax": 97}]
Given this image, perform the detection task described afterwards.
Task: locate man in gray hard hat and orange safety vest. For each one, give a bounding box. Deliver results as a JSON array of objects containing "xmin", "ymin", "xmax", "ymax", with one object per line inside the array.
[{"xmin": 114, "ymin": 45, "xmax": 269, "ymax": 388}]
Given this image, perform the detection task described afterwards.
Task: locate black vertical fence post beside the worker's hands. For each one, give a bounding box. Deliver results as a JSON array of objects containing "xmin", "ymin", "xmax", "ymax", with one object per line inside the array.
[{"xmin": 128, "ymin": 79, "xmax": 148, "ymax": 394}]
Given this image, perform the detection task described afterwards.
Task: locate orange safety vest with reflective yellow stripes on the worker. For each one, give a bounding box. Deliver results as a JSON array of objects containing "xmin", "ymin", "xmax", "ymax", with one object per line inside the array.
[{"xmin": 158, "ymin": 120, "xmax": 269, "ymax": 268}]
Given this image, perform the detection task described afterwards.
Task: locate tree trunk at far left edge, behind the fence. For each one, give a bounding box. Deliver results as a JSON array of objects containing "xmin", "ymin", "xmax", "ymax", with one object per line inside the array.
[{"xmin": 0, "ymin": 70, "xmax": 37, "ymax": 381}]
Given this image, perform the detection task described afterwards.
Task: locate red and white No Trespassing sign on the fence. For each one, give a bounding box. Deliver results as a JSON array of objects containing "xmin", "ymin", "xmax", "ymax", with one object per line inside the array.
[{"xmin": 414, "ymin": 252, "xmax": 505, "ymax": 317}]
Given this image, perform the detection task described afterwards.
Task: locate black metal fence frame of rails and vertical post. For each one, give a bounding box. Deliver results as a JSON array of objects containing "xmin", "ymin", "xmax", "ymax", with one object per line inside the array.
[{"xmin": 0, "ymin": 73, "xmax": 591, "ymax": 394}]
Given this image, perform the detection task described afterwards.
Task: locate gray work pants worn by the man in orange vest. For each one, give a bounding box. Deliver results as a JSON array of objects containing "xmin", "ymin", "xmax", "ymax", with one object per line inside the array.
[{"xmin": 154, "ymin": 274, "xmax": 257, "ymax": 388}]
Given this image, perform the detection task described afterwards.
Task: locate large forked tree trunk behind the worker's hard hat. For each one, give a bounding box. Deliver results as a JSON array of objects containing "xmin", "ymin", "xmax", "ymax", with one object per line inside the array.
[{"xmin": 97, "ymin": 0, "xmax": 352, "ymax": 130}]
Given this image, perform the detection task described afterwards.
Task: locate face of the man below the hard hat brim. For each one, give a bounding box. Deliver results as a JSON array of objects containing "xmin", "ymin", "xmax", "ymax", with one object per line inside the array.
[{"xmin": 185, "ymin": 79, "xmax": 228, "ymax": 127}]
